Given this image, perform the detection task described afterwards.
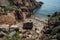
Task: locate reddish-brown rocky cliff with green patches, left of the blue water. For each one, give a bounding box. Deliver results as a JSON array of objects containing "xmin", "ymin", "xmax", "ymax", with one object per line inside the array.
[{"xmin": 0, "ymin": 0, "xmax": 43, "ymax": 24}]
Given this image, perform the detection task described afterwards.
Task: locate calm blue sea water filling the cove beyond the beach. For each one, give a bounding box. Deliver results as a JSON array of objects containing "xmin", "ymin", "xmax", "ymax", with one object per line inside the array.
[{"xmin": 35, "ymin": 0, "xmax": 60, "ymax": 19}]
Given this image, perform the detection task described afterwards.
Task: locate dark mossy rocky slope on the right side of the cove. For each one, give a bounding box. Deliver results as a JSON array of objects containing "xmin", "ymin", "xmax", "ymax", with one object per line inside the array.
[{"xmin": 42, "ymin": 12, "xmax": 60, "ymax": 40}]
